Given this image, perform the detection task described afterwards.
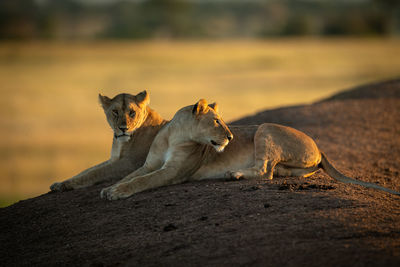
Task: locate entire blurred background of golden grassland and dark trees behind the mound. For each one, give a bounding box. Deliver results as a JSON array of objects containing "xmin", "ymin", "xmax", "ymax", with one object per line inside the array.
[{"xmin": 0, "ymin": 0, "xmax": 400, "ymax": 206}]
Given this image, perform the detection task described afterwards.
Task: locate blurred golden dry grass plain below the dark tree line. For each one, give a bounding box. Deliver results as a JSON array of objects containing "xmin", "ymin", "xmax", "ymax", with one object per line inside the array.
[{"xmin": 0, "ymin": 39, "xmax": 400, "ymax": 206}]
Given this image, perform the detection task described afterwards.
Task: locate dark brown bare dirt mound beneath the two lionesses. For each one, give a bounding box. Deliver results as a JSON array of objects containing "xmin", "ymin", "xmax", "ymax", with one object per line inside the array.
[{"xmin": 0, "ymin": 80, "xmax": 400, "ymax": 266}]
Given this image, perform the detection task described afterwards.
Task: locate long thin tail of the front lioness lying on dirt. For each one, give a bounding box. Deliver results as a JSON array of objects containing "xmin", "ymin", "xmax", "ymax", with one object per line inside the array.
[{"xmin": 319, "ymin": 151, "xmax": 400, "ymax": 196}]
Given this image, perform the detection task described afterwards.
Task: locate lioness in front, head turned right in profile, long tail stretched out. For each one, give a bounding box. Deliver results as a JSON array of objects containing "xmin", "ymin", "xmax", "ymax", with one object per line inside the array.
[{"xmin": 101, "ymin": 99, "xmax": 399, "ymax": 200}]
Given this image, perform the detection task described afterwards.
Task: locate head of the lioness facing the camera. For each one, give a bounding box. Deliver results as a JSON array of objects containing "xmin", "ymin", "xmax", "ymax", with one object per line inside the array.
[{"xmin": 99, "ymin": 91, "xmax": 150, "ymax": 142}]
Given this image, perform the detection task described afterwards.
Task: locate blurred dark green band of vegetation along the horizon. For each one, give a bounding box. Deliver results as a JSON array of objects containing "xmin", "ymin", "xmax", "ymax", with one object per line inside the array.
[{"xmin": 0, "ymin": 0, "xmax": 400, "ymax": 39}]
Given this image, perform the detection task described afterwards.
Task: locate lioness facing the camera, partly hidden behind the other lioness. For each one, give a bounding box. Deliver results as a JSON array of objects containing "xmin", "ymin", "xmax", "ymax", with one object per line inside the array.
[{"xmin": 50, "ymin": 91, "xmax": 166, "ymax": 191}]
